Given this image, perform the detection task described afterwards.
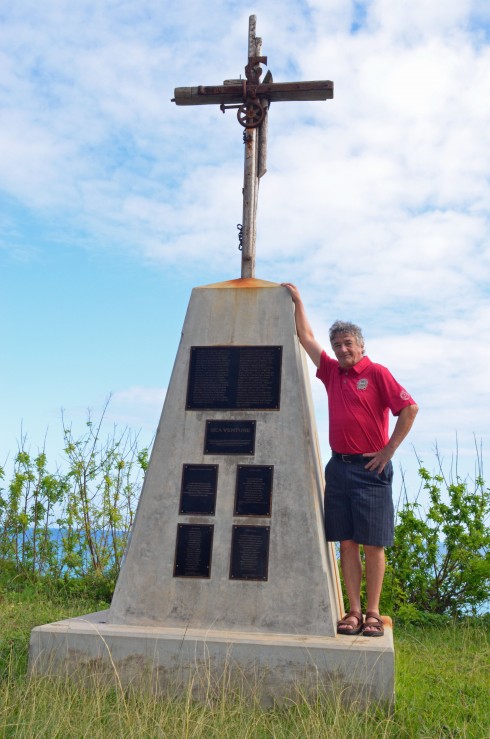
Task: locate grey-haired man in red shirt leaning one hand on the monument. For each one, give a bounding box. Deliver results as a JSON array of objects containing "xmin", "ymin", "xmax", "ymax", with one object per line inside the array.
[{"xmin": 283, "ymin": 282, "xmax": 418, "ymax": 636}]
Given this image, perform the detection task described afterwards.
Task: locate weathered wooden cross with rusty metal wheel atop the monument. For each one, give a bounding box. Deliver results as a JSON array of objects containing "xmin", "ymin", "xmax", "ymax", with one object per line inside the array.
[{"xmin": 172, "ymin": 15, "xmax": 333, "ymax": 277}]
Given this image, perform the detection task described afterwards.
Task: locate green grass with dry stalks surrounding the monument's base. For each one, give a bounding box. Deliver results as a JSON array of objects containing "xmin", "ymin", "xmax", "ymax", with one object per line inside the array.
[{"xmin": 0, "ymin": 588, "xmax": 490, "ymax": 739}]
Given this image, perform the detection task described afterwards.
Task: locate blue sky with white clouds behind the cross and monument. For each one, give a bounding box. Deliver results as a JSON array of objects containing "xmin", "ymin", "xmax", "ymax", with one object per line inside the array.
[{"xmin": 0, "ymin": 0, "xmax": 490, "ymax": 497}]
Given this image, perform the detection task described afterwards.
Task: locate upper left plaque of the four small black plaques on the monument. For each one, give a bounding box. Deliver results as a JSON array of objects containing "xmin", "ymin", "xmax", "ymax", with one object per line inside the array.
[{"xmin": 179, "ymin": 464, "xmax": 218, "ymax": 516}]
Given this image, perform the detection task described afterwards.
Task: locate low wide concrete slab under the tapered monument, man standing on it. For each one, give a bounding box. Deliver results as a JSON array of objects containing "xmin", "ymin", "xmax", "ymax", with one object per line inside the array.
[{"xmin": 29, "ymin": 611, "xmax": 394, "ymax": 710}]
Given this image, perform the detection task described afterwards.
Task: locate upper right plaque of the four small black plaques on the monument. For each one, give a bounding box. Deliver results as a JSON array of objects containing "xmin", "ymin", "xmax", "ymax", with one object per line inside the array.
[{"xmin": 234, "ymin": 464, "xmax": 274, "ymax": 516}]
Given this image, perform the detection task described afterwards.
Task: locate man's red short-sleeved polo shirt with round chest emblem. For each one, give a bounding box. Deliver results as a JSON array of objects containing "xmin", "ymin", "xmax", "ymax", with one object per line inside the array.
[{"xmin": 316, "ymin": 351, "xmax": 415, "ymax": 454}]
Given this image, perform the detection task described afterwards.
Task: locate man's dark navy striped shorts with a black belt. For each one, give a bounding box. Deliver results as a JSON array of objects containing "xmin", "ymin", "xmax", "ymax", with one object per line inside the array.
[{"xmin": 324, "ymin": 457, "xmax": 395, "ymax": 547}]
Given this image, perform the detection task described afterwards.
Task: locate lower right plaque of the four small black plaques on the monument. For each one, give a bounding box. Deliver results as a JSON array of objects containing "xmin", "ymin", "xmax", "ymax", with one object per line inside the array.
[{"xmin": 230, "ymin": 526, "xmax": 270, "ymax": 580}]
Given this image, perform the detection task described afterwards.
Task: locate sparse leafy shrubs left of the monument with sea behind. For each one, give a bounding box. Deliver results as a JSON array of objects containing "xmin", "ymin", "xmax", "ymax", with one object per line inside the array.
[{"xmin": 0, "ymin": 405, "xmax": 148, "ymax": 597}]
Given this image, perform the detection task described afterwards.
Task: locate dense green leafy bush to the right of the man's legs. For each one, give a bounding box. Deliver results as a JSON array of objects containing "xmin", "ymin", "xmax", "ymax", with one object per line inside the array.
[{"xmin": 383, "ymin": 452, "xmax": 490, "ymax": 623}]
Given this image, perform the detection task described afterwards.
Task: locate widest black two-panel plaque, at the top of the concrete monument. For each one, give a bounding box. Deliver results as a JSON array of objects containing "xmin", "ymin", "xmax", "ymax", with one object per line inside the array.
[{"xmin": 186, "ymin": 346, "xmax": 282, "ymax": 410}]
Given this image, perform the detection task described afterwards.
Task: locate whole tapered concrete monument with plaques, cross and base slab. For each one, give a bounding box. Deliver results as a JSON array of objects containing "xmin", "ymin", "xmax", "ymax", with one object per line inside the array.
[{"xmin": 29, "ymin": 16, "xmax": 394, "ymax": 704}]
